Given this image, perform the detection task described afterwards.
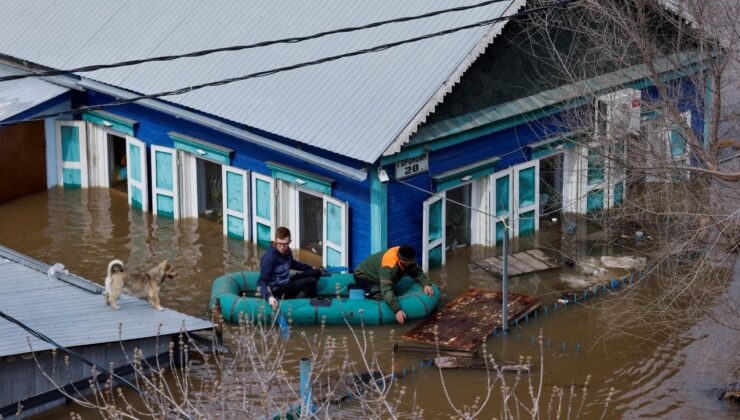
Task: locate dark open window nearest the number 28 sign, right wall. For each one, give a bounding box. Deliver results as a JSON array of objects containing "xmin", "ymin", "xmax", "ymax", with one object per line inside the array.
[{"xmin": 445, "ymin": 184, "xmax": 472, "ymax": 249}]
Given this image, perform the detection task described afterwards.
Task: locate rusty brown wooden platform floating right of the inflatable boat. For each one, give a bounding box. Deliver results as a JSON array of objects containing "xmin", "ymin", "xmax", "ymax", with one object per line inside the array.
[{"xmin": 397, "ymin": 289, "xmax": 539, "ymax": 357}]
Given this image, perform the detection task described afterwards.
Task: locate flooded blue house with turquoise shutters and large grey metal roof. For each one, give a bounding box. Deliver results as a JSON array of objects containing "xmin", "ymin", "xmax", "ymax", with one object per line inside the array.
[{"xmin": 0, "ymin": 0, "xmax": 704, "ymax": 269}]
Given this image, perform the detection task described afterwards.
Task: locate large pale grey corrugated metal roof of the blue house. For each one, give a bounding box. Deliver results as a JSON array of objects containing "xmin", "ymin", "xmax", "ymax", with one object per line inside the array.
[{"xmin": 0, "ymin": 0, "xmax": 524, "ymax": 162}]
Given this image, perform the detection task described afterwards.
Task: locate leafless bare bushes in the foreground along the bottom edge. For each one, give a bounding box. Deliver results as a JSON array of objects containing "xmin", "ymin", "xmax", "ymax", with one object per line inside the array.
[{"xmin": 26, "ymin": 322, "xmax": 613, "ymax": 419}]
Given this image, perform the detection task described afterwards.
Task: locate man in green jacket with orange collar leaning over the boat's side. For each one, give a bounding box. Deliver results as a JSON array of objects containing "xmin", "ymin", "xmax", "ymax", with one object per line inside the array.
[{"xmin": 354, "ymin": 245, "xmax": 434, "ymax": 324}]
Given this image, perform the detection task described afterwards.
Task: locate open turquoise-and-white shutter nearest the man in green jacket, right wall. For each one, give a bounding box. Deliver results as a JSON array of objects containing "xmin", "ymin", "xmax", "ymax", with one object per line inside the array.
[{"xmin": 421, "ymin": 192, "xmax": 445, "ymax": 271}]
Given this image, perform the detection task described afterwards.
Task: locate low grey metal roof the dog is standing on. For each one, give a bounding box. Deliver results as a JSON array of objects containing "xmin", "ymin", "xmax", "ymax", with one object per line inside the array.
[{"xmin": 0, "ymin": 247, "xmax": 212, "ymax": 357}]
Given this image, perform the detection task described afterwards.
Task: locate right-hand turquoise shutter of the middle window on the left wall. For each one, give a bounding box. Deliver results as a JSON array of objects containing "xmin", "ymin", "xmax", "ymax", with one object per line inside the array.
[{"xmin": 221, "ymin": 166, "xmax": 249, "ymax": 240}]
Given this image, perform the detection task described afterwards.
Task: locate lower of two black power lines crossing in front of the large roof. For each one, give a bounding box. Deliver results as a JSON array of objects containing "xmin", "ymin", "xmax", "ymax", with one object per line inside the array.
[{"xmin": 0, "ymin": 0, "xmax": 576, "ymax": 126}]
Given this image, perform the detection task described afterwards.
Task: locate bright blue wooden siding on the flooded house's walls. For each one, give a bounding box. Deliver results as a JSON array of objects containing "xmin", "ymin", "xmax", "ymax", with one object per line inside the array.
[{"xmin": 75, "ymin": 72, "xmax": 704, "ymax": 267}]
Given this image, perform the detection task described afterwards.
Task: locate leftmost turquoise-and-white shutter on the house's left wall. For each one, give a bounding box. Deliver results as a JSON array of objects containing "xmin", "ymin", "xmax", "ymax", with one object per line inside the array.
[{"xmin": 56, "ymin": 121, "xmax": 89, "ymax": 188}]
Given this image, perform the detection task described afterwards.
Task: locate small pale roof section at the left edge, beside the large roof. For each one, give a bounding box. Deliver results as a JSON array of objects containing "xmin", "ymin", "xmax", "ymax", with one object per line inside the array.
[{"xmin": 0, "ymin": 64, "xmax": 69, "ymax": 121}]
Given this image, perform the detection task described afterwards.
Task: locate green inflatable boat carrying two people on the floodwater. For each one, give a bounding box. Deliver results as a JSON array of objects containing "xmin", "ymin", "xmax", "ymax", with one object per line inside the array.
[{"xmin": 211, "ymin": 271, "xmax": 440, "ymax": 325}]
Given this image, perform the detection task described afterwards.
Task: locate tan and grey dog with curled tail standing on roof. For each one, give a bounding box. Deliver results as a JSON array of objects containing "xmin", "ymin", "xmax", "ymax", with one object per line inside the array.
[{"xmin": 103, "ymin": 260, "xmax": 176, "ymax": 311}]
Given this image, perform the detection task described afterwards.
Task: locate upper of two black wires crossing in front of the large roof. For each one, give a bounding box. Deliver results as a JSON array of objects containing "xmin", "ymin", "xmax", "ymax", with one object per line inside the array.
[{"xmin": 0, "ymin": 0, "xmax": 506, "ymax": 82}]
